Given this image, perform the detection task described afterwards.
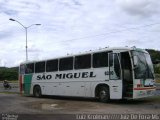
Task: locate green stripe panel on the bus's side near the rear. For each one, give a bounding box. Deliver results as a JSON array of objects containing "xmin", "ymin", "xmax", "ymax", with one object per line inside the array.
[{"xmin": 24, "ymin": 74, "xmax": 33, "ymax": 95}]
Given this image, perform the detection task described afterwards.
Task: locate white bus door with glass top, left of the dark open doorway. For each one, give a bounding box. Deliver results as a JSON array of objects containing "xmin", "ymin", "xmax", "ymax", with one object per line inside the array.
[{"xmin": 109, "ymin": 53, "xmax": 122, "ymax": 99}]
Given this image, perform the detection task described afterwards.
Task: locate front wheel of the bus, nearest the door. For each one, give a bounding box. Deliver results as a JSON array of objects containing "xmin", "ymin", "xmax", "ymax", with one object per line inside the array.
[{"xmin": 99, "ymin": 86, "xmax": 110, "ymax": 103}]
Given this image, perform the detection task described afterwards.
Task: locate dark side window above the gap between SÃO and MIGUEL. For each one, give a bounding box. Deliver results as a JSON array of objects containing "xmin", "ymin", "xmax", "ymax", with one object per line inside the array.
[{"xmin": 46, "ymin": 60, "xmax": 58, "ymax": 72}]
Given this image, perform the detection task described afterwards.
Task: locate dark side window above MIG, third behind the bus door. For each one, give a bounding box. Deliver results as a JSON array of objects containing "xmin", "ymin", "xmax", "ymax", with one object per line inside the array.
[{"xmin": 59, "ymin": 57, "xmax": 73, "ymax": 71}]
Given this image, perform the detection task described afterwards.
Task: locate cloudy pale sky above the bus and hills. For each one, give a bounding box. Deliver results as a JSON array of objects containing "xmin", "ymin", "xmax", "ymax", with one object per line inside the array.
[{"xmin": 0, "ymin": 0, "xmax": 160, "ymax": 67}]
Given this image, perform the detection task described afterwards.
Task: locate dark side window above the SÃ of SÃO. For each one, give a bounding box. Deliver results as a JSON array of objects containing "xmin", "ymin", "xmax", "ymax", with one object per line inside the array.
[{"xmin": 35, "ymin": 61, "xmax": 45, "ymax": 73}]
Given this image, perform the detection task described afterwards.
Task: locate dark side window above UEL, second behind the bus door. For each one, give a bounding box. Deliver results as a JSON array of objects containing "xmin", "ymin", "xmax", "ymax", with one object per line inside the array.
[{"xmin": 74, "ymin": 54, "xmax": 91, "ymax": 69}]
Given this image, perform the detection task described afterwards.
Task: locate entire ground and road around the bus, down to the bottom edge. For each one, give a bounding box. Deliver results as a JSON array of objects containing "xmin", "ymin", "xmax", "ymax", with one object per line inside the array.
[{"xmin": 0, "ymin": 84, "xmax": 160, "ymax": 120}]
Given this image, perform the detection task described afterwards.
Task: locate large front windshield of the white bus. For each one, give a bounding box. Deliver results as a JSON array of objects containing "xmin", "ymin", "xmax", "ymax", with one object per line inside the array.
[{"xmin": 132, "ymin": 51, "xmax": 154, "ymax": 79}]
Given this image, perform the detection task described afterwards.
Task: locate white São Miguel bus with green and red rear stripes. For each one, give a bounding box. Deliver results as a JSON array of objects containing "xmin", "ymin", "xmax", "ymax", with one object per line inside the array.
[{"xmin": 19, "ymin": 47, "xmax": 156, "ymax": 102}]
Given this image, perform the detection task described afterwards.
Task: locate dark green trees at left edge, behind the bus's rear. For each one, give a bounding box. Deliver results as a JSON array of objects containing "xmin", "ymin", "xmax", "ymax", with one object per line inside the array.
[{"xmin": 0, "ymin": 67, "xmax": 18, "ymax": 81}]
